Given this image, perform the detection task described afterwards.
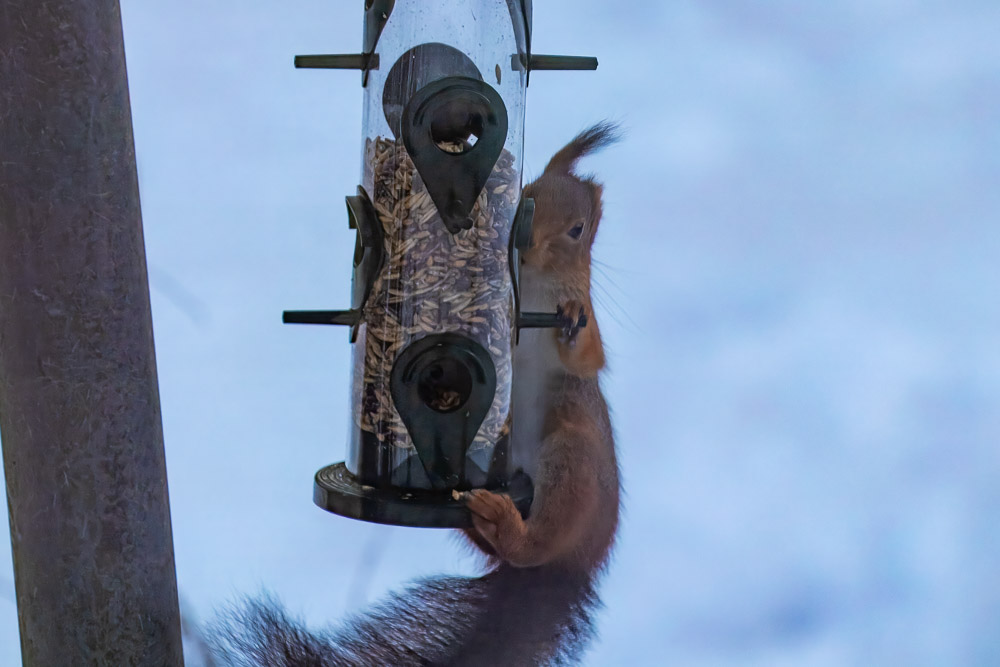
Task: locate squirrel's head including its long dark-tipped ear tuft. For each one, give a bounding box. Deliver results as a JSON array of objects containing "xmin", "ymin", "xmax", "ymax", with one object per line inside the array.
[{"xmin": 521, "ymin": 122, "xmax": 619, "ymax": 278}]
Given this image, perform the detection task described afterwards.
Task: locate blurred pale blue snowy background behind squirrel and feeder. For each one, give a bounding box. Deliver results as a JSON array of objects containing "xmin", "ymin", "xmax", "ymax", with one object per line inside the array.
[{"xmin": 0, "ymin": 0, "xmax": 1000, "ymax": 666}]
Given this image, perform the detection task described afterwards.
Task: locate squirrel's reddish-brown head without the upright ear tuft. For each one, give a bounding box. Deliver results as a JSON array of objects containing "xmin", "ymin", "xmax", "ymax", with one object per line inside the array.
[{"xmin": 521, "ymin": 171, "xmax": 602, "ymax": 273}]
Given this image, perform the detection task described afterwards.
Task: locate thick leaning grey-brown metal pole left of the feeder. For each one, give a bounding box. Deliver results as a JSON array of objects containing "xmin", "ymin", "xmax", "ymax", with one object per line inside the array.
[{"xmin": 0, "ymin": 0, "xmax": 183, "ymax": 667}]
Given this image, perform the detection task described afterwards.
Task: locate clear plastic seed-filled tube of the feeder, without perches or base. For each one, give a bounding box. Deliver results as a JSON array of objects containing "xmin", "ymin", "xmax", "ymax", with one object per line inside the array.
[{"xmin": 347, "ymin": 0, "xmax": 525, "ymax": 489}]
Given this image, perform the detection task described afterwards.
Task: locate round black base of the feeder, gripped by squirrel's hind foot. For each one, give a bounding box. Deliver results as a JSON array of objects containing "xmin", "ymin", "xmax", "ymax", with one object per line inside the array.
[{"xmin": 313, "ymin": 463, "xmax": 533, "ymax": 528}]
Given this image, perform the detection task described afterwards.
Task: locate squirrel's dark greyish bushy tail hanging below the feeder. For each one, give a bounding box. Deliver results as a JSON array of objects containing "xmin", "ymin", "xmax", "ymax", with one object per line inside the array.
[{"xmin": 209, "ymin": 566, "xmax": 599, "ymax": 667}]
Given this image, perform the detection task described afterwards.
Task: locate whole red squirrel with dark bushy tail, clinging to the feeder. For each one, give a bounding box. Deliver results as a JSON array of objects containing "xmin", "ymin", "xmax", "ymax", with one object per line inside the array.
[{"xmin": 209, "ymin": 123, "xmax": 619, "ymax": 667}]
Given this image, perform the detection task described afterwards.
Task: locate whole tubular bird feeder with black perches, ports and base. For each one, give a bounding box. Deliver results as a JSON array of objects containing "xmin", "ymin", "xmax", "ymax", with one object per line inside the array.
[{"xmin": 283, "ymin": 0, "xmax": 597, "ymax": 528}]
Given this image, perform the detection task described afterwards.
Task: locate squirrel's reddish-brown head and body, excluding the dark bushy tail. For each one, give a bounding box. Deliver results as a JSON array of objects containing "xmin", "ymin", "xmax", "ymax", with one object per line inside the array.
[{"xmin": 467, "ymin": 125, "xmax": 619, "ymax": 575}]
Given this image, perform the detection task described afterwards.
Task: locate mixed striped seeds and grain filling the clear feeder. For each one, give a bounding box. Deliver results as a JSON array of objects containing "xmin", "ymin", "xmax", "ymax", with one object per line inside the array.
[{"xmin": 352, "ymin": 138, "xmax": 520, "ymax": 454}]
